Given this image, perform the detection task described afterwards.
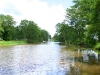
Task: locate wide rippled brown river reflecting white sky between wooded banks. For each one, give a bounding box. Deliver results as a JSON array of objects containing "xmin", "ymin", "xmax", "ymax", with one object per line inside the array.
[{"xmin": 0, "ymin": 42, "xmax": 100, "ymax": 75}]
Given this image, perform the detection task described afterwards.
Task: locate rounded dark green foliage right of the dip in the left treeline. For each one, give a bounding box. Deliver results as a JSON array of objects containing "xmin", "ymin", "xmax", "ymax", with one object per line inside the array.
[{"xmin": 17, "ymin": 20, "xmax": 49, "ymax": 43}]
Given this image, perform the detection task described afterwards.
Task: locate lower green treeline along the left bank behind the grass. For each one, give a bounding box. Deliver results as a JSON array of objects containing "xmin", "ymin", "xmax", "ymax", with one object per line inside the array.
[{"xmin": 0, "ymin": 14, "xmax": 51, "ymax": 43}]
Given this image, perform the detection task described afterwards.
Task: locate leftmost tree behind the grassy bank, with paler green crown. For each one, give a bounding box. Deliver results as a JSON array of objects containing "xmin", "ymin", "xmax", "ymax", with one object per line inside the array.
[{"xmin": 0, "ymin": 14, "xmax": 16, "ymax": 41}]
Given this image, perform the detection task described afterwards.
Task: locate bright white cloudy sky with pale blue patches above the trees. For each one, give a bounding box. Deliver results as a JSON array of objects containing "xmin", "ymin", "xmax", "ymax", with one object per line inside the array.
[{"xmin": 0, "ymin": 0, "xmax": 73, "ymax": 36}]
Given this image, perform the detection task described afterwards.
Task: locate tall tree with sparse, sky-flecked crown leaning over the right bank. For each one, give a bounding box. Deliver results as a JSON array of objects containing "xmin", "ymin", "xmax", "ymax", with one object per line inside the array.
[{"xmin": 66, "ymin": 1, "xmax": 87, "ymax": 45}]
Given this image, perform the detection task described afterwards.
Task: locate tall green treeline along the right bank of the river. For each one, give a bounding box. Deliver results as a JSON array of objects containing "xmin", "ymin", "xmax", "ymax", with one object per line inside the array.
[{"xmin": 53, "ymin": 0, "xmax": 100, "ymax": 47}]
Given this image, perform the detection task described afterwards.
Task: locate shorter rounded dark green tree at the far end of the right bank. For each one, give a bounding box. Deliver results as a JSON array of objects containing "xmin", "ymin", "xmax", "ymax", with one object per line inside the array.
[{"xmin": 53, "ymin": 22, "xmax": 76, "ymax": 44}]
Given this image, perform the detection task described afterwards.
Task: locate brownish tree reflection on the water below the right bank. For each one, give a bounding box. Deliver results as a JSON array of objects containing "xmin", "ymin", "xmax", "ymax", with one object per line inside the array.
[{"xmin": 61, "ymin": 48, "xmax": 100, "ymax": 75}]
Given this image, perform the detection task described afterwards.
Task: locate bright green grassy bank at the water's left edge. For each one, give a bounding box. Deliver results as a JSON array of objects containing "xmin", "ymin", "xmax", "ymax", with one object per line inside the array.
[{"xmin": 0, "ymin": 41, "xmax": 27, "ymax": 46}]
